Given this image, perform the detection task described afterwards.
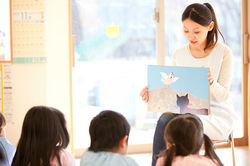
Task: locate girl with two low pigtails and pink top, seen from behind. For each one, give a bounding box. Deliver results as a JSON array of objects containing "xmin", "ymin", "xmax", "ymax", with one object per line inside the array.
[{"xmin": 156, "ymin": 114, "xmax": 223, "ymax": 166}]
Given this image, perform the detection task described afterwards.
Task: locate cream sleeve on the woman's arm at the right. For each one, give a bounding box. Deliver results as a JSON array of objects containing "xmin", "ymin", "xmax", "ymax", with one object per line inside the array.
[{"xmin": 210, "ymin": 48, "xmax": 233, "ymax": 101}]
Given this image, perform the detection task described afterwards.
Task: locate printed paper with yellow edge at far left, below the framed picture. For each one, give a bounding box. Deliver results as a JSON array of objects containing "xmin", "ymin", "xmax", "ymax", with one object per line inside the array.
[{"xmin": 0, "ymin": 64, "xmax": 14, "ymax": 124}]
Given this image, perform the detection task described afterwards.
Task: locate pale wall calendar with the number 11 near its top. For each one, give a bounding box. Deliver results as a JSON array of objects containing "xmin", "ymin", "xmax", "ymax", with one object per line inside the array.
[{"xmin": 12, "ymin": 0, "xmax": 46, "ymax": 63}]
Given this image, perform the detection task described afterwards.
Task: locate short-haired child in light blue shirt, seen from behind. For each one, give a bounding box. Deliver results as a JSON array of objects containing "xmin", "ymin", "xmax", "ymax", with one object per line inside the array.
[{"xmin": 80, "ymin": 110, "xmax": 137, "ymax": 166}]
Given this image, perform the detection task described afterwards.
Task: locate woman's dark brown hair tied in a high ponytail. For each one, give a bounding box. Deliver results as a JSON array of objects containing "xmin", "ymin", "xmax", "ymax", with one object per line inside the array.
[{"xmin": 182, "ymin": 3, "xmax": 224, "ymax": 50}]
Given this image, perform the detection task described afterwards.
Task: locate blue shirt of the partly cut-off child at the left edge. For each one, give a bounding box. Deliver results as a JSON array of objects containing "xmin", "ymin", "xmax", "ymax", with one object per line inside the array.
[{"xmin": 0, "ymin": 137, "xmax": 16, "ymax": 166}]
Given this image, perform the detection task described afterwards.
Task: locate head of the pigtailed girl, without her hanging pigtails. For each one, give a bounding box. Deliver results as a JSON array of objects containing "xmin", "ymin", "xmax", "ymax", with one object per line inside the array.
[{"xmin": 164, "ymin": 114, "xmax": 203, "ymax": 156}]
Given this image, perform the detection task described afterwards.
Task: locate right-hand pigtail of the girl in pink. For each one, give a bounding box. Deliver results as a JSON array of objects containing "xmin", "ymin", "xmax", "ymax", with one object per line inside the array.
[{"xmin": 203, "ymin": 134, "xmax": 223, "ymax": 166}]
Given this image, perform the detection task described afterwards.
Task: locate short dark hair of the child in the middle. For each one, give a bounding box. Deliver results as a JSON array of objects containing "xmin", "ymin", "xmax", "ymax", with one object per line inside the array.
[{"xmin": 89, "ymin": 110, "xmax": 130, "ymax": 152}]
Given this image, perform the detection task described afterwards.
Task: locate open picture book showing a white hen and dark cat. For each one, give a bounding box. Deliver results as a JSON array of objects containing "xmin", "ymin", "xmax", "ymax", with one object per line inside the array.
[{"xmin": 148, "ymin": 65, "xmax": 210, "ymax": 115}]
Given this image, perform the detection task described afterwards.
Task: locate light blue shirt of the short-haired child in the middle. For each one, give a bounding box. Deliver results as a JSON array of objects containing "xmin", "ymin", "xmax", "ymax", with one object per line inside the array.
[{"xmin": 80, "ymin": 151, "xmax": 138, "ymax": 166}]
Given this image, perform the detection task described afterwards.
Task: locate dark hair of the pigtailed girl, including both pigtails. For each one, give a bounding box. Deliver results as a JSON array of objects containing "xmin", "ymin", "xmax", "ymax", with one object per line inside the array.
[{"xmin": 162, "ymin": 114, "xmax": 223, "ymax": 166}]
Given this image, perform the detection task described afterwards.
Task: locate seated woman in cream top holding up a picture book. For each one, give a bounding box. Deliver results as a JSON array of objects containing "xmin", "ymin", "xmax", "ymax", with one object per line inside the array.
[{"xmin": 140, "ymin": 3, "xmax": 236, "ymax": 166}]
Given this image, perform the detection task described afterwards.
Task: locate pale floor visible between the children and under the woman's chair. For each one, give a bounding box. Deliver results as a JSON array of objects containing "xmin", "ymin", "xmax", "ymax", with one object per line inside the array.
[{"xmin": 77, "ymin": 146, "xmax": 250, "ymax": 166}]
